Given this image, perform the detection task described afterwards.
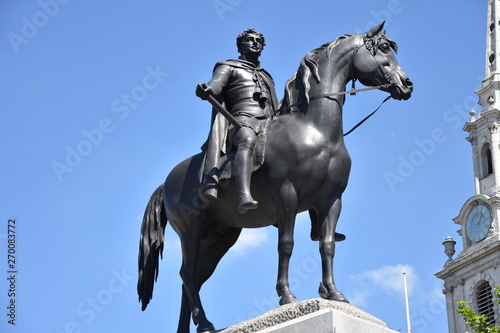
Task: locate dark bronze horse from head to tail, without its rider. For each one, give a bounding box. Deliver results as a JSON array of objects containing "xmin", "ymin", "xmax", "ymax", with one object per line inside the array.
[{"xmin": 138, "ymin": 22, "xmax": 413, "ymax": 333}]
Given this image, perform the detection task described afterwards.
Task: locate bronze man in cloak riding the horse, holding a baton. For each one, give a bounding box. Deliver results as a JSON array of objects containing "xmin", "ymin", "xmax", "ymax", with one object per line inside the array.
[{"xmin": 196, "ymin": 29, "xmax": 278, "ymax": 214}]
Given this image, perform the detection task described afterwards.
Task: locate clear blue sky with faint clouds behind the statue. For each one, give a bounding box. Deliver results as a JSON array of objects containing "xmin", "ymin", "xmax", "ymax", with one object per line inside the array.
[{"xmin": 0, "ymin": 0, "xmax": 487, "ymax": 333}]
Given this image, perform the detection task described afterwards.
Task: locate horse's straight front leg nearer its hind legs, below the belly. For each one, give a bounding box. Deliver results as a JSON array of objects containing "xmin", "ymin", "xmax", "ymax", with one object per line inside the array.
[{"xmin": 276, "ymin": 183, "xmax": 298, "ymax": 305}]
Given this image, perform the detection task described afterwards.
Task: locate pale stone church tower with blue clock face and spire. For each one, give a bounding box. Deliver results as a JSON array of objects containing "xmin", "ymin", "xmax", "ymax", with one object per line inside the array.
[{"xmin": 436, "ymin": 0, "xmax": 500, "ymax": 333}]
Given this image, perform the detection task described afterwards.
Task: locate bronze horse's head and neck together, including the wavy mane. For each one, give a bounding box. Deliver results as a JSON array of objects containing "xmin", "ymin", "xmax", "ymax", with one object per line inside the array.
[{"xmin": 280, "ymin": 22, "xmax": 413, "ymax": 112}]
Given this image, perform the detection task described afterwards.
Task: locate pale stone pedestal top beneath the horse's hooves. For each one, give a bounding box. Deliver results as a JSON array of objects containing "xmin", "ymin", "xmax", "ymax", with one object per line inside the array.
[{"xmin": 217, "ymin": 299, "xmax": 396, "ymax": 333}]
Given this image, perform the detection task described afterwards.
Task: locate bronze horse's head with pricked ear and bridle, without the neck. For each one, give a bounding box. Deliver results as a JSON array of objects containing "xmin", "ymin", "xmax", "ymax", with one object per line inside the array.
[{"xmin": 352, "ymin": 22, "xmax": 413, "ymax": 100}]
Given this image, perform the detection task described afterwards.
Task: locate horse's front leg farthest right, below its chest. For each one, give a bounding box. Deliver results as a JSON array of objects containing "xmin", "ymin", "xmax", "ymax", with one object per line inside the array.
[{"xmin": 319, "ymin": 197, "xmax": 349, "ymax": 302}]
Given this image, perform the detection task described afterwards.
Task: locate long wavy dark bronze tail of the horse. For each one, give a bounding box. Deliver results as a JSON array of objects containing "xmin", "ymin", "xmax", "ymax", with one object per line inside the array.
[{"xmin": 137, "ymin": 184, "xmax": 167, "ymax": 311}]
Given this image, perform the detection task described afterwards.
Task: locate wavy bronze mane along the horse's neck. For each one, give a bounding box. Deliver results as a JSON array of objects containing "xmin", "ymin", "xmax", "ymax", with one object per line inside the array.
[{"xmin": 280, "ymin": 35, "xmax": 351, "ymax": 111}]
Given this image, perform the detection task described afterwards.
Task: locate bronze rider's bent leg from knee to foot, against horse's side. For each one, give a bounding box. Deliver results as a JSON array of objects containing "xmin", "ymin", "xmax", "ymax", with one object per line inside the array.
[{"xmin": 233, "ymin": 127, "xmax": 258, "ymax": 214}]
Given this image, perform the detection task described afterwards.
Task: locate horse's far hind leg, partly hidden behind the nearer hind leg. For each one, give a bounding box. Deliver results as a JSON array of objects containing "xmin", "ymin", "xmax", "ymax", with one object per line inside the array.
[{"xmin": 177, "ymin": 228, "xmax": 241, "ymax": 333}]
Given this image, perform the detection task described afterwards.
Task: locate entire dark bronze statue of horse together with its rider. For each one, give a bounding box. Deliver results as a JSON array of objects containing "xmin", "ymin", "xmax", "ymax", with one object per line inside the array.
[{"xmin": 137, "ymin": 22, "xmax": 413, "ymax": 333}]
